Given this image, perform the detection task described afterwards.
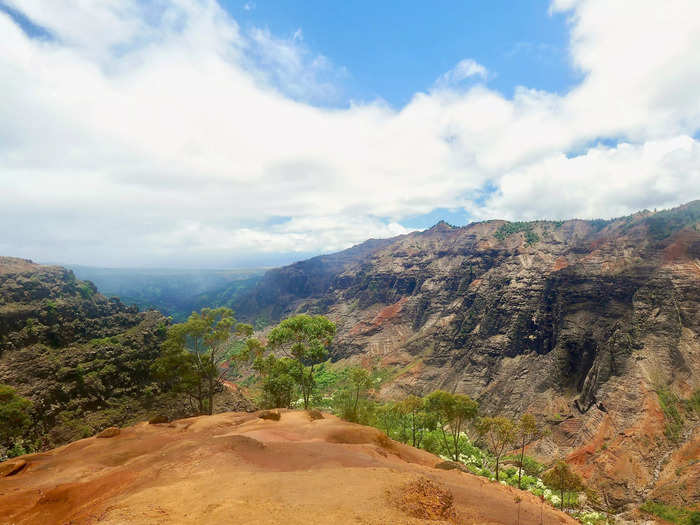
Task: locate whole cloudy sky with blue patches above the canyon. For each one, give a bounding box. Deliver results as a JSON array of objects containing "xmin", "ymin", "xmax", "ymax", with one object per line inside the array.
[{"xmin": 0, "ymin": 0, "xmax": 700, "ymax": 268}]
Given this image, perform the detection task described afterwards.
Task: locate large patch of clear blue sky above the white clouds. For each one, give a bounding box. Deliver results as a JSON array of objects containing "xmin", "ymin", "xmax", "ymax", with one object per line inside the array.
[{"xmin": 227, "ymin": 0, "xmax": 580, "ymax": 107}]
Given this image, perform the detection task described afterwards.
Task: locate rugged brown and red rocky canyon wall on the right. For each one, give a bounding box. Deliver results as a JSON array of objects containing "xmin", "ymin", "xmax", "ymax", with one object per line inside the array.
[{"xmin": 235, "ymin": 201, "xmax": 700, "ymax": 506}]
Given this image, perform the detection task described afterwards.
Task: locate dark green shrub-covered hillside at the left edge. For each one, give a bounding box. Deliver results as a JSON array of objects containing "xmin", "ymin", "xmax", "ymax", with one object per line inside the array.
[{"xmin": 0, "ymin": 257, "xmax": 252, "ymax": 450}]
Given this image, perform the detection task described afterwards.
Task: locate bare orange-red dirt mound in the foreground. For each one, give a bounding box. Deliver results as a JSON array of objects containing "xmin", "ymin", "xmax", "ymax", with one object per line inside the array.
[{"xmin": 0, "ymin": 411, "xmax": 576, "ymax": 525}]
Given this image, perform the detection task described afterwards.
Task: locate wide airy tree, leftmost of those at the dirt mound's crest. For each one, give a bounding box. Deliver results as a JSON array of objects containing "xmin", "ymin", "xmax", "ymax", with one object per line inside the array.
[{"xmin": 152, "ymin": 307, "xmax": 253, "ymax": 414}]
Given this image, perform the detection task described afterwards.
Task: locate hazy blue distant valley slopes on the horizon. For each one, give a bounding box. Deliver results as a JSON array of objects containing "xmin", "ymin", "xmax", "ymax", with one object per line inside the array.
[{"xmin": 70, "ymin": 266, "xmax": 264, "ymax": 322}]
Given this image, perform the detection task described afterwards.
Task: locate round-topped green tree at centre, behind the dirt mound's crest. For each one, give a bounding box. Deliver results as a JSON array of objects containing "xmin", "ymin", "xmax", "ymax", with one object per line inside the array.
[{"xmin": 267, "ymin": 314, "xmax": 335, "ymax": 409}]
